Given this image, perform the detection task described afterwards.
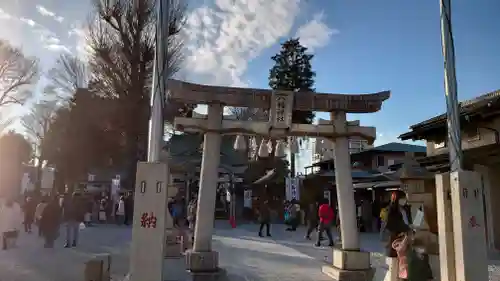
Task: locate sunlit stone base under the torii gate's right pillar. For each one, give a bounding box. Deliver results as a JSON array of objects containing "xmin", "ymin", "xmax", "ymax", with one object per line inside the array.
[{"xmin": 322, "ymin": 249, "xmax": 375, "ymax": 281}]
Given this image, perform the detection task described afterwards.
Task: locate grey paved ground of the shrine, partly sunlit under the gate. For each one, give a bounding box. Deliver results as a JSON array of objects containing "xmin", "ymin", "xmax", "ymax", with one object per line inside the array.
[{"xmin": 0, "ymin": 222, "xmax": 500, "ymax": 281}]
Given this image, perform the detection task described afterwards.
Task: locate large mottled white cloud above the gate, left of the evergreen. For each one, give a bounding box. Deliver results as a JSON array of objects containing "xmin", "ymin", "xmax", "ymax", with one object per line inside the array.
[{"xmin": 184, "ymin": 0, "xmax": 300, "ymax": 86}]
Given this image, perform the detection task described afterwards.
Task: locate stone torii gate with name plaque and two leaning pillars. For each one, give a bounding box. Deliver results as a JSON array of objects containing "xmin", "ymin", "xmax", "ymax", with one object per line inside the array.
[{"xmin": 168, "ymin": 80, "xmax": 390, "ymax": 280}]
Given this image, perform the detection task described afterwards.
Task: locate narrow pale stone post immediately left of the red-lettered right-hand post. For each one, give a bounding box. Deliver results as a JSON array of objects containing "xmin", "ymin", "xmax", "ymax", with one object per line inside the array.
[{"xmin": 436, "ymin": 173, "xmax": 456, "ymax": 281}]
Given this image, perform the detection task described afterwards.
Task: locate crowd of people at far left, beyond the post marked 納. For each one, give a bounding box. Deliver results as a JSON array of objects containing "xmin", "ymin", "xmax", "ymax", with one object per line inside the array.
[{"xmin": 0, "ymin": 192, "xmax": 133, "ymax": 250}]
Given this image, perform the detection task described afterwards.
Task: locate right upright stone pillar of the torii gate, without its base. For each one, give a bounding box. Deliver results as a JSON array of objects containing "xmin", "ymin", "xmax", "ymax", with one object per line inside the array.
[{"xmin": 330, "ymin": 112, "xmax": 359, "ymax": 250}]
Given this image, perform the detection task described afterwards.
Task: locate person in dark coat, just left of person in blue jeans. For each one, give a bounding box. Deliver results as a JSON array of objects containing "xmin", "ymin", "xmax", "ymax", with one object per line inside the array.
[{"xmin": 39, "ymin": 197, "xmax": 62, "ymax": 248}]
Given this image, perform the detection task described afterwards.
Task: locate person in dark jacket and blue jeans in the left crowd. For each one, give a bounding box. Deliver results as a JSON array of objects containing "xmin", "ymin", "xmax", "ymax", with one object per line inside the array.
[{"xmin": 63, "ymin": 192, "xmax": 85, "ymax": 248}]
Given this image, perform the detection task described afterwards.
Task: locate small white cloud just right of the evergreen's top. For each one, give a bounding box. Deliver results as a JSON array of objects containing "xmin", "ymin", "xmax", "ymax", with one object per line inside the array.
[{"xmin": 295, "ymin": 12, "xmax": 339, "ymax": 51}]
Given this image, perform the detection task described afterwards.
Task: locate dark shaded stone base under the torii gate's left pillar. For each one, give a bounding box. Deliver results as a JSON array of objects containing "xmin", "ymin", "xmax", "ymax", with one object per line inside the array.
[{"xmin": 186, "ymin": 250, "xmax": 226, "ymax": 281}]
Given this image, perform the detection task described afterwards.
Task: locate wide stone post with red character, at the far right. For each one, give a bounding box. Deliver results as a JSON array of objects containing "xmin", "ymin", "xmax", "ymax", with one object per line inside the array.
[{"xmin": 450, "ymin": 170, "xmax": 489, "ymax": 281}]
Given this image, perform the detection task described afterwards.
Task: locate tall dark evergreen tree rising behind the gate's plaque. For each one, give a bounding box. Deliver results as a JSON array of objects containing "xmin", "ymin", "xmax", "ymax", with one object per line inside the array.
[{"xmin": 269, "ymin": 38, "xmax": 316, "ymax": 124}]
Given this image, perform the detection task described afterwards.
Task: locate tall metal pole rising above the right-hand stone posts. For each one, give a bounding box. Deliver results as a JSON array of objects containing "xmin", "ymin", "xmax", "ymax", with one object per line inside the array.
[{"xmin": 440, "ymin": 0, "xmax": 463, "ymax": 172}]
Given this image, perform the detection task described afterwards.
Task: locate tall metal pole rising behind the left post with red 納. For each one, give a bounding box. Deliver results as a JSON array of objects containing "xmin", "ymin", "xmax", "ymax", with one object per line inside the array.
[{"xmin": 148, "ymin": 0, "xmax": 170, "ymax": 162}]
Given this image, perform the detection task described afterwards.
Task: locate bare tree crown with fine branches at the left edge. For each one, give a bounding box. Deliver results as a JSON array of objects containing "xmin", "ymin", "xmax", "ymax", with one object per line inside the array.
[{"xmin": 0, "ymin": 40, "xmax": 39, "ymax": 107}]
